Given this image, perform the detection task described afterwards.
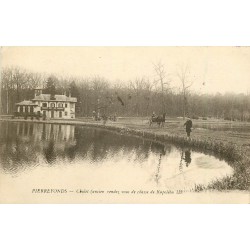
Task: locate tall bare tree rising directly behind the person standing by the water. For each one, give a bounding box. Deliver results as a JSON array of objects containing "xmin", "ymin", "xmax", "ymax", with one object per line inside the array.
[{"xmin": 177, "ymin": 64, "xmax": 193, "ymax": 119}]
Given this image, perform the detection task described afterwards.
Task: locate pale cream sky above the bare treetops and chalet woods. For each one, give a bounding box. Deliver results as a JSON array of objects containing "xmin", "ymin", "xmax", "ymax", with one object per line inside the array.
[{"xmin": 0, "ymin": 47, "xmax": 250, "ymax": 93}]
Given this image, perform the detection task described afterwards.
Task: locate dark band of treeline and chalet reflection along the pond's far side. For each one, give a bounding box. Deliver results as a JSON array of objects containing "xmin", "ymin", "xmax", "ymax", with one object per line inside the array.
[{"xmin": 0, "ymin": 122, "xmax": 176, "ymax": 175}]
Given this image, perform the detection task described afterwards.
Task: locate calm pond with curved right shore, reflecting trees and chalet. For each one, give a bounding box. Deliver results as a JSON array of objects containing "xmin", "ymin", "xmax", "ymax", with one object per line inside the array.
[{"xmin": 0, "ymin": 121, "xmax": 233, "ymax": 191}]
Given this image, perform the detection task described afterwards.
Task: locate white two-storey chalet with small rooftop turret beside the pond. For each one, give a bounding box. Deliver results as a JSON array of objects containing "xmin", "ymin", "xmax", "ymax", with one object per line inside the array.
[{"xmin": 16, "ymin": 88, "xmax": 77, "ymax": 119}]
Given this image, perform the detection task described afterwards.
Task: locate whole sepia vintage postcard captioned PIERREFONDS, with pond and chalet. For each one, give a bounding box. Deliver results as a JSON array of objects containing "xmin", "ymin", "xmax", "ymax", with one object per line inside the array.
[{"xmin": 0, "ymin": 47, "xmax": 250, "ymax": 204}]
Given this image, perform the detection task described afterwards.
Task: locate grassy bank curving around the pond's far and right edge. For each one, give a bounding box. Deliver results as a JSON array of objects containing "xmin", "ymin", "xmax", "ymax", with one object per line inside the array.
[{"xmin": 0, "ymin": 118, "xmax": 250, "ymax": 191}]
